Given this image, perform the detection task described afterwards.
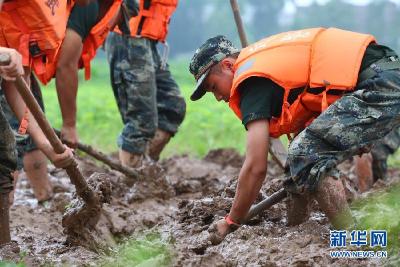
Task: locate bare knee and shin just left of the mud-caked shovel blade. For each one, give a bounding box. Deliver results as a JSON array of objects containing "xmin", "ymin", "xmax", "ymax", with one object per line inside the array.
[{"xmin": 24, "ymin": 149, "xmax": 53, "ymax": 202}]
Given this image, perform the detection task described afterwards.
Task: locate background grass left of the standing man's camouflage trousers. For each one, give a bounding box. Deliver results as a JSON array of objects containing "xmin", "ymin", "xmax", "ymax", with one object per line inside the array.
[{"xmin": 42, "ymin": 60, "xmax": 122, "ymax": 152}]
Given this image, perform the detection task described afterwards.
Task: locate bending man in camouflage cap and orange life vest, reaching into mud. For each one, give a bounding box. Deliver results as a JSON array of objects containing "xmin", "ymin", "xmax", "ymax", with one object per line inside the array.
[{"xmin": 190, "ymin": 28, "xmax": 400, "ymax": 240}]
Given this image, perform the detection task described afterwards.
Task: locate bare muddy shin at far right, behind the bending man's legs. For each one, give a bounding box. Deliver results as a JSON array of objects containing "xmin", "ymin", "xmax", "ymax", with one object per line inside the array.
[{"xmin": 353, "ymin": 153, "xmax": 374, "ymax": 192}]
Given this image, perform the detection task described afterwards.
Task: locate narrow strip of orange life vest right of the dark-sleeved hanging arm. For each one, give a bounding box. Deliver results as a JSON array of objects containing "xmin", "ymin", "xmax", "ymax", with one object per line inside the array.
[{"xmin": 81, "ymin": 0, "xmax": 121, "ymax": 80}]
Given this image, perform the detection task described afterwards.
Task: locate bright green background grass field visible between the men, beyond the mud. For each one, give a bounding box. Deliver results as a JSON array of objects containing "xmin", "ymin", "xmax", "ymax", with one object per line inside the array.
[{"xmin": 42, "ymin": 56, "xmax": 245, "ymax": 157}]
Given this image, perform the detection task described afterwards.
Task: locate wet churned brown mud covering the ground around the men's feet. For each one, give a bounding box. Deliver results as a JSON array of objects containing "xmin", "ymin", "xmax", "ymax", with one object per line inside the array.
[{"xmin": 0, "ymin": 150, "xmax": 400, "ymax": 266}]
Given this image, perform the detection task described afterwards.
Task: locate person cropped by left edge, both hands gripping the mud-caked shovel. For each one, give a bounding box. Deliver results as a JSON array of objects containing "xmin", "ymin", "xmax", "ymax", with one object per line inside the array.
[{"xmin": 0, "ymin": 47, "xmax": 73, "ymax": 245}]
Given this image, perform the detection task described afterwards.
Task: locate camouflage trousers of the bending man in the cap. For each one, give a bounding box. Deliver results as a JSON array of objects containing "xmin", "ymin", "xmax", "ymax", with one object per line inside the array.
[{"xmin": 286, "ymin": 70, "xmax": 400, "ymax": 191}]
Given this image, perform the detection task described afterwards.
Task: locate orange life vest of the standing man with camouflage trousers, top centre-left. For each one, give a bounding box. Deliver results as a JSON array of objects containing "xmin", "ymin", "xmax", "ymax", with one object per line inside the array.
[{"xmin": 121, "ymin": 0, "xmax": 178, "ymax": 42}]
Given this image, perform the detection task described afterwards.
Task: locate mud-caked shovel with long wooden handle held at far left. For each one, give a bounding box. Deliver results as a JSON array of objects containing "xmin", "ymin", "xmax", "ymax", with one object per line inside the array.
[{"xmin": 0, "ymin": 54, "xmax": 109, "ymax": 247}]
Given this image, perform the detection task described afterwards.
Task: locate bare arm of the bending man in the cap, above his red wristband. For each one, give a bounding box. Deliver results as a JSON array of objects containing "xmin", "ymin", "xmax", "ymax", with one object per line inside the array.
[{"xmin": 229, "ymin": 120, "xmax": 269, "ymax": 222}]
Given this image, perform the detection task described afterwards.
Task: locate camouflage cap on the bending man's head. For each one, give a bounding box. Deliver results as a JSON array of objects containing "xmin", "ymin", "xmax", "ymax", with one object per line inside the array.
[{"xmin": 189, "ymin": 35, "xmax": 240, "ymax": 101}]
